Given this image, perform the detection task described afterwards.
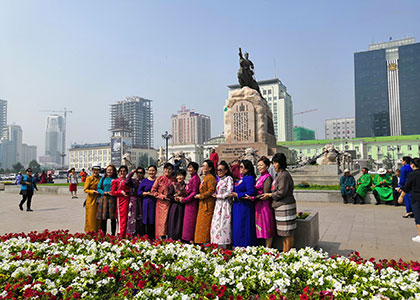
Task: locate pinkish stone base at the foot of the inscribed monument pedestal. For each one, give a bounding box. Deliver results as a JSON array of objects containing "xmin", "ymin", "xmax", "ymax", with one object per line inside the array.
[{"xmin": 216, "ymin": 143, "xmax": 292, "ymax": 163}]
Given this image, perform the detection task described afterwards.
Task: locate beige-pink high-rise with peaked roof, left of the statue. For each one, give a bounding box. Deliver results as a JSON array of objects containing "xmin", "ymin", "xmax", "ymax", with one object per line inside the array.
[{"xmin": 171, "ymin": 106, "xmax": 211, "ymax": 145}]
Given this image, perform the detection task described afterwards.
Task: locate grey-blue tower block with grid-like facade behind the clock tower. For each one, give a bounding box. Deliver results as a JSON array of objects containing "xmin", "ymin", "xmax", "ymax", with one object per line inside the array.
[{"xmin": 110, "ymin": 96, "xmax": 153, "ymax": 148}]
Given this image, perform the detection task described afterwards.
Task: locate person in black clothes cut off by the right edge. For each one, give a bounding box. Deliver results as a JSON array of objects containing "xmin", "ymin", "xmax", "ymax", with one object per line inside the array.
[{"xmin": 398, "ymin": 158, "xmax": 420, "ymax": 243}]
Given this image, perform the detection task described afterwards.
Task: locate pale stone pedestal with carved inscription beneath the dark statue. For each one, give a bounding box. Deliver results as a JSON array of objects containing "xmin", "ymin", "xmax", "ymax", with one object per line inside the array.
[{"xmin": 217, "ymin": 87, "xmax": 290, "ymax": 162}]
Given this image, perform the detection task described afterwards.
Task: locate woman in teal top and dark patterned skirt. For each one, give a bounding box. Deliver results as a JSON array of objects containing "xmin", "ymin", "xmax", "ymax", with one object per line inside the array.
[{"xmin": 96, "ymin": 165, "xmax": 117, "ymax": 235}]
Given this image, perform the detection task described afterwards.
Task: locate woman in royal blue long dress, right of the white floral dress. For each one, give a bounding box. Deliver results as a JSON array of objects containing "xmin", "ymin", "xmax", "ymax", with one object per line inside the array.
[{"xmin": 231, "ymin": 160, "xmax": 257, "ymax": 247}]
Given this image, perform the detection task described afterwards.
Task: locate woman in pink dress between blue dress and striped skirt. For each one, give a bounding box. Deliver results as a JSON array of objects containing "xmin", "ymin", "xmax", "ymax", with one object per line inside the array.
[{"xmin": 244, "ymin": 156, "xmax": 275, "ymax": 248}]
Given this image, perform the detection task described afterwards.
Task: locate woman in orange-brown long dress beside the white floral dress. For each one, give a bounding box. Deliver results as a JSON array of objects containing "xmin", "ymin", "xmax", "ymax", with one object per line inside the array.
[{"xmin": 194, "ymin": 159, "xmax": 217, "ymax": 244}]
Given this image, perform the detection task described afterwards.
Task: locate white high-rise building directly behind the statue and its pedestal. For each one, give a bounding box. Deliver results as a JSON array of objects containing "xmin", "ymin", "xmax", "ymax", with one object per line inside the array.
[{"xmin": 228, "ymin": 78, "xmax": 293, "ymax": 141}]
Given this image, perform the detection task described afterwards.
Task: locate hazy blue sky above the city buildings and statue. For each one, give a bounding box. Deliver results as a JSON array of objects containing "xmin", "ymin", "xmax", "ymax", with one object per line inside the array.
[{"xmin": 0, "ymin": 0, "xmax": 420, "ymax": 155}]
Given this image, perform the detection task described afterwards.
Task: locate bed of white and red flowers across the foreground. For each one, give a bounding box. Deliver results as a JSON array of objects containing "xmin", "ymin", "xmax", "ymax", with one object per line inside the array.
[{"xmin": 0, "ymin": 231, "xmax": 420, "ymax": 299}]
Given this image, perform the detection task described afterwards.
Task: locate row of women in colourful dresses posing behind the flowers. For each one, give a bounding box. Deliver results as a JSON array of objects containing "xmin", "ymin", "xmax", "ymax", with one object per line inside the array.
[{"xmin": 84, "ymin": 153, "xmax": 296, "ymax": 252}]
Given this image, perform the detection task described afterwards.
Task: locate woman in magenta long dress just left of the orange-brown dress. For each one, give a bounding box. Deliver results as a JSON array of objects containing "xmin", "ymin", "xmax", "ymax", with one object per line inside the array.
[{"xmin": 179, "ymin": 162, "xmax": 200, "ymax": 243}]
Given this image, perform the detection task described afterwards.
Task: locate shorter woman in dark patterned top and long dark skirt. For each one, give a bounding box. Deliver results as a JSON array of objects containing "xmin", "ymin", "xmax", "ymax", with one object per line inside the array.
[{"xmin": 168, "ymin": 169, "xmax": 187, "ymax": 240}]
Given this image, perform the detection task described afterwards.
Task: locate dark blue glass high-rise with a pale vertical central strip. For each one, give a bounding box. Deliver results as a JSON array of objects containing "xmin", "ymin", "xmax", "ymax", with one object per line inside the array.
[{"xmin": 354, "ymin": 38, "xmax": 420, "ymax": 137}]
